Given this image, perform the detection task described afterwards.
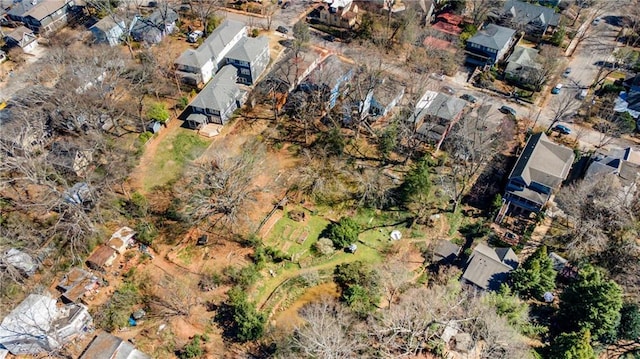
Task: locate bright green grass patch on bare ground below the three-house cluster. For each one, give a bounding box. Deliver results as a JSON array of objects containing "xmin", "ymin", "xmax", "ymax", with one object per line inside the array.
[{"xmin": 144, "ymin": 128, "xmax": 211, "ymax": 191}]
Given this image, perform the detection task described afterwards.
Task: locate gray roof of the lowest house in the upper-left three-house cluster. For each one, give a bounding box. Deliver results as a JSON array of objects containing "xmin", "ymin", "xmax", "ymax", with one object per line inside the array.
[{"xmin": 189, "ymin": 65, "xmax": 240, "ymax": 111}]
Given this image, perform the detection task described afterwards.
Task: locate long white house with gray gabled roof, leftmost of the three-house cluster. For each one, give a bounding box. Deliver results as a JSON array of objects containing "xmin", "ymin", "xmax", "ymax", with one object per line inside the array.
[{"xmin": 174, "ymin": 20, "xmax": 247, "ymax": 86}]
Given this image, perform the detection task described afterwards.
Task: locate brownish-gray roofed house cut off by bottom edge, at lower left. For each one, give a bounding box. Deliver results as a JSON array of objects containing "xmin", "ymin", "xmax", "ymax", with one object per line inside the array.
[{"xmin": 79, "ymin": 332, "xmax": 151, "ymax": 359}]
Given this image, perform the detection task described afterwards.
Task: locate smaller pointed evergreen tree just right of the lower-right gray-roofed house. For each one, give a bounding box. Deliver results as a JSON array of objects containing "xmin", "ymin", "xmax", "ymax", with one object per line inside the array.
[{"xmin": 511, "ymin": 246, "xmax": 556, "ymax": 299}]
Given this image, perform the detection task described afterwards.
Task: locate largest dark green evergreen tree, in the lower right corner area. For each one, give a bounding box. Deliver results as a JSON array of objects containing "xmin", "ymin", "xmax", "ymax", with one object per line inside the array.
[{"xmin": 558, "ymin": 266, "xmax": 622, "ymax": 341}]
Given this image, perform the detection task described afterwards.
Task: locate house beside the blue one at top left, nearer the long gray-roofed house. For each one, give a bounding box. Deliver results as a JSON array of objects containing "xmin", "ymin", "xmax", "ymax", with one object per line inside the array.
[{"xmin": 131, "ymin": 6, "xmax": 178, "ymax": 45}]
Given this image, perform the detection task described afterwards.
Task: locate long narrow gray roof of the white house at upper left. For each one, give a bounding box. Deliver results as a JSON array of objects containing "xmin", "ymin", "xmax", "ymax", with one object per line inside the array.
[{"xmin": 175, "ymin": 20, "xmax": 248, "ymax": 68}]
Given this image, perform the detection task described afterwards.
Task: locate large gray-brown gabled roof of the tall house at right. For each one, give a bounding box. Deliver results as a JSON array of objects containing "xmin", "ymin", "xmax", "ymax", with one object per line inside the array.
[{"xmin": 509, "ymin": 132, "xmax": 574, "ymax": 188}]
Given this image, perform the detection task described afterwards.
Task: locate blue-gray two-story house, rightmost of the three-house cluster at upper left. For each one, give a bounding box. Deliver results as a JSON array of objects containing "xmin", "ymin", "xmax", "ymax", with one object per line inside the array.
[{"xmin": 225, "ymin": 36, "xmax": 270, "ymax": 85}]
